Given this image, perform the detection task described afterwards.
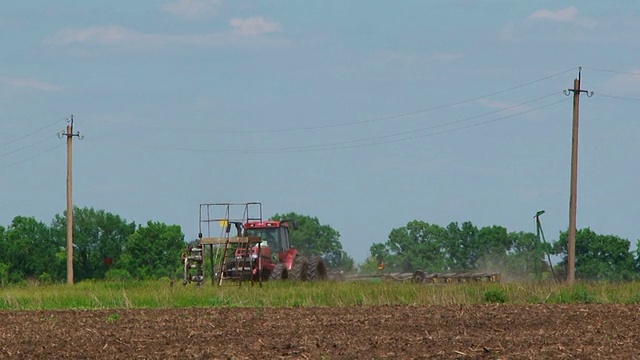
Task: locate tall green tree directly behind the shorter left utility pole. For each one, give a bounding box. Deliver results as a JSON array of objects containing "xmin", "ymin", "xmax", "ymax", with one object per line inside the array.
[{"xmin": 52, "ymin": 207, "xmax": 135, "ymax": 281}]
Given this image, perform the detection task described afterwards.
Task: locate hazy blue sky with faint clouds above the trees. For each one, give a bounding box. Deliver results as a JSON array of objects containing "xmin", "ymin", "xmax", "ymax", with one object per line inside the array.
[{"xmin": 0, "ymin": 0, "xmax": 640, "ymax": 262}]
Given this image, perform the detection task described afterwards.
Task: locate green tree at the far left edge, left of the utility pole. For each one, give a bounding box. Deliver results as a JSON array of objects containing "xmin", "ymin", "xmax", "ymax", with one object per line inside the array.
[{"xmin": 0, "ymin": 216, "xmax": 64, "ymax": 282}]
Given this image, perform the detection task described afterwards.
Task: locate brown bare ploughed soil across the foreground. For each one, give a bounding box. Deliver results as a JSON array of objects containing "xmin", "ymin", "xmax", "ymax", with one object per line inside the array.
[{"xmin": 0, "ymin": 305, "xmax": 640, "ymax": 359}]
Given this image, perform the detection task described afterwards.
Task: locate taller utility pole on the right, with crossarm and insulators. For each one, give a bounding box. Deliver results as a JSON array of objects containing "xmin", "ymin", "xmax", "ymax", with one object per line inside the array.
[{"xmin": 564, "ymin": 67, "xmax": 593, "ymax": 285}]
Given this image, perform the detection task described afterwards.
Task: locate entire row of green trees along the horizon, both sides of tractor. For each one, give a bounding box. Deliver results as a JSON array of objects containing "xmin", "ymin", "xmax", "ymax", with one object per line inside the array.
[{"xmin": 0, "ymin": 207, "xmax": 640, "ymax": 285}]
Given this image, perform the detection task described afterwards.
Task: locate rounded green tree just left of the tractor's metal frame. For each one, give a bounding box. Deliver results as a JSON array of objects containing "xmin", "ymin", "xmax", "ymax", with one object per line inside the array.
[{"xmin": 122, "ymin": 221, "xmax": 186, "ymax": 279}]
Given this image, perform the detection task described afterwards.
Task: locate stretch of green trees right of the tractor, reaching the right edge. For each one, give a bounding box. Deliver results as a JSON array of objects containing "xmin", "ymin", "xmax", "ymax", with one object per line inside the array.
[{"xmin": 361, "ymin": 220, "xmax": 640, "ymax": 281}]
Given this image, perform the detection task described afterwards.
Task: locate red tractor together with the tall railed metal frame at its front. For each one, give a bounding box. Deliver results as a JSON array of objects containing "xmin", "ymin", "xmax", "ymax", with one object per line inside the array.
[{"xmin": 182, "ymin": 202, "xmax": 327, "ymax": 285}]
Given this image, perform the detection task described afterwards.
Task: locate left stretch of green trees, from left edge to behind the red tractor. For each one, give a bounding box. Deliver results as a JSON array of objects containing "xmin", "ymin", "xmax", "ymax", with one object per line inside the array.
[{"xmin": 0, "ymin": 207, "xmax": 354, "ymax": 285}]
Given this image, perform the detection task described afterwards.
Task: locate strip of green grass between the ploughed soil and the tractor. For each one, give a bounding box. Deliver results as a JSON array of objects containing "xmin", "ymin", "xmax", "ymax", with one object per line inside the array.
[{"xmin": 0, "ymin": 281, "xmax": 640, "ymax": 310}]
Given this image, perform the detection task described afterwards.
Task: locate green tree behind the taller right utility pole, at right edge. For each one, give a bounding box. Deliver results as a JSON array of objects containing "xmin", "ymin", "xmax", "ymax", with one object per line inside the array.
[{"xmin": 554, "ymin": 228, "xmax": 638, "ymax": 281}]
